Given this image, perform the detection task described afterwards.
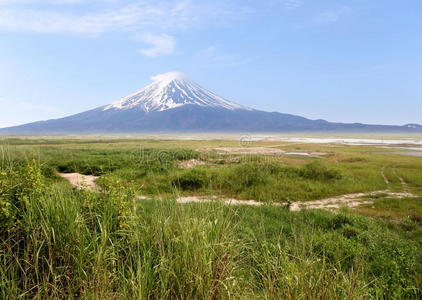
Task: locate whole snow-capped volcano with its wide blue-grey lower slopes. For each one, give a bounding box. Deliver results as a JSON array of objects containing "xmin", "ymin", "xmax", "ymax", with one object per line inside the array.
[{"xmin": 0, "ymin": 72, "xmax": 422, "ymax": 135}]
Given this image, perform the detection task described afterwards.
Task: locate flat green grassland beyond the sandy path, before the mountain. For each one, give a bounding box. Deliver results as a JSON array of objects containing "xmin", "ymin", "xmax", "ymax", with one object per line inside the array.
[{"xmin": 3, "ymin": 138, "xmax": 422, "ymax": 209}]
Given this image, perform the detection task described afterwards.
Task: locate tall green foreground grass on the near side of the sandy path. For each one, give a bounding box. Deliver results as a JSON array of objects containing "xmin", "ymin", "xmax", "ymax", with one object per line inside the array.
[{"xmin": 0, "ymin": 148, "xmax": 422, "ymax": 299}]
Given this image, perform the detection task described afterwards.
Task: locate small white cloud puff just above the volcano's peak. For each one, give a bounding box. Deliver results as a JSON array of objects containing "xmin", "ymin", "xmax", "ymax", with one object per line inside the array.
[{"xmin": 139, "ymin": 33, "xmax": 175, "ymax": 57}]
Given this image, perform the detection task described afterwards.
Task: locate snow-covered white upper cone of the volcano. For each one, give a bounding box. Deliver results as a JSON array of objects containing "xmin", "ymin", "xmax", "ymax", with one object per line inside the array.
[{"xmin": 104, "ymin": 72, "xmax": 251, "ymax": 113}]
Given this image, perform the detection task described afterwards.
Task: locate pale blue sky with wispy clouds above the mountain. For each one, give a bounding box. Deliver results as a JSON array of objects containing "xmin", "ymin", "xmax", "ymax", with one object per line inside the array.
[{"xmin": 0, "ymin": 0, "xmax": 422, "ymax": 127}]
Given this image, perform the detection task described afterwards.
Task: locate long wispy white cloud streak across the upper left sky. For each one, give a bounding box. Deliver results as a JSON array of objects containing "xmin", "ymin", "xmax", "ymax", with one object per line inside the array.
[{"xmin": 0, "ymin": 1, "xmax": 196, "ymax": 34}]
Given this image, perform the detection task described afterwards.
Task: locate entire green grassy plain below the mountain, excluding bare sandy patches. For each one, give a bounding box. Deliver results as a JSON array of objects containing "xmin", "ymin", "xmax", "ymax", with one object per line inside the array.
[{"xmin": 0, "ymin": 138, "xmax": 422, "ymax": 299}]
